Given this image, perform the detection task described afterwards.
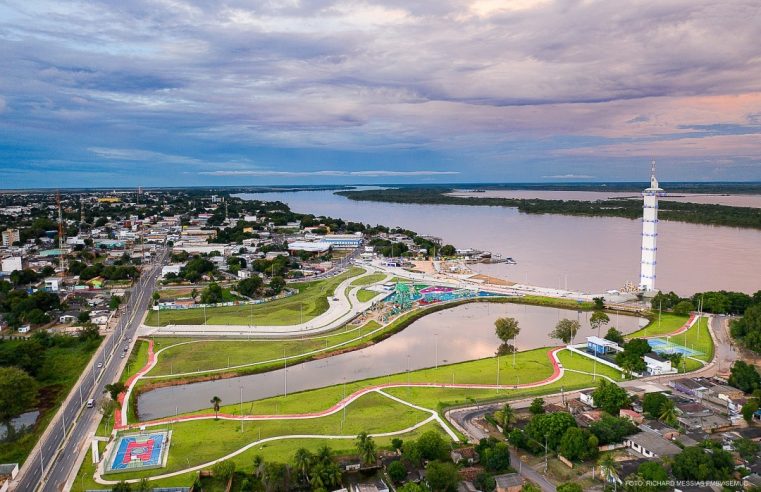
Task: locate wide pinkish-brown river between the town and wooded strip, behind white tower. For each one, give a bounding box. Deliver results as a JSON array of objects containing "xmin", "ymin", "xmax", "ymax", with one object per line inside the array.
[{"xmin": 239, "ymin": 191, "xmax": 761, "ymax": 296}]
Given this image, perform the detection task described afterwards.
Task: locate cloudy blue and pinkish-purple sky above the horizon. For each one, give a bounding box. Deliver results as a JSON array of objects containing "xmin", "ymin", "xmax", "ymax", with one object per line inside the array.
[{"xmin": 0, "ymin": 0, "xmax": 761, "ymax": 189}]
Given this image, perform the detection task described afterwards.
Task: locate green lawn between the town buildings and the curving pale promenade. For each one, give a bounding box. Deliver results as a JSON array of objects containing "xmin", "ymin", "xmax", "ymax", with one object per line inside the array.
[{"xmin": 145, "ymin": 267, "xmax": 365, "ymax": 326}]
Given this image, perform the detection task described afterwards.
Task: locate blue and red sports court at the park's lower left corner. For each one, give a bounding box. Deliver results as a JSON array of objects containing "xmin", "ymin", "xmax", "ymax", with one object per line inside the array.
[{"xmin": 106, "ymin": 430, "xmax": 171, "ymax": 473}]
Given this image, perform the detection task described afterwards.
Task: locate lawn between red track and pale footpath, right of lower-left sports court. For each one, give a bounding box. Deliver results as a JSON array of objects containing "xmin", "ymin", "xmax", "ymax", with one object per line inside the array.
[{"xmin": 109, "ymin": 393, "xmax": 430, "ymax": 478}]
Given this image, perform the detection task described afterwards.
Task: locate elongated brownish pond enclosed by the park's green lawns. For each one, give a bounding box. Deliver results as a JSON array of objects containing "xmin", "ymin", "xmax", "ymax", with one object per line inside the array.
[{"xmin": 138, "ymin": 303, "xmax": 646, "ymax": 420}]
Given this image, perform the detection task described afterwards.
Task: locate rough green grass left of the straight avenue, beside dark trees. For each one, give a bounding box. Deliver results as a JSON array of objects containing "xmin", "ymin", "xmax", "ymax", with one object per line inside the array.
[{"xmin": 0, "ymin": 339, "xmax": 100, "ymax": 465}]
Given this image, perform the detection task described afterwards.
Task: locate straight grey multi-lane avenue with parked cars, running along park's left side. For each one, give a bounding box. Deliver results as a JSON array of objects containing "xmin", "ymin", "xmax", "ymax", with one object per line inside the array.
[{"xmin": 13, "ymin": 252, "xmax": 167, "ymax": 492}]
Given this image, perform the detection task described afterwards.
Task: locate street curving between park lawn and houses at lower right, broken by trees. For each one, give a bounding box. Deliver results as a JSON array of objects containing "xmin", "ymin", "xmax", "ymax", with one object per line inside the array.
[{"xmin": 446, "ymin": 316, "xmax": 738, "ymax": 492}]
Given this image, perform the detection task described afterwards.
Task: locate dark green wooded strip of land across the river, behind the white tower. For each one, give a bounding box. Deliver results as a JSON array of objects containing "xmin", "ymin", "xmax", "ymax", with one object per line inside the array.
[{"xmin": 337, "ymin": 187, "xmax": 761, "ymax": 229}]
